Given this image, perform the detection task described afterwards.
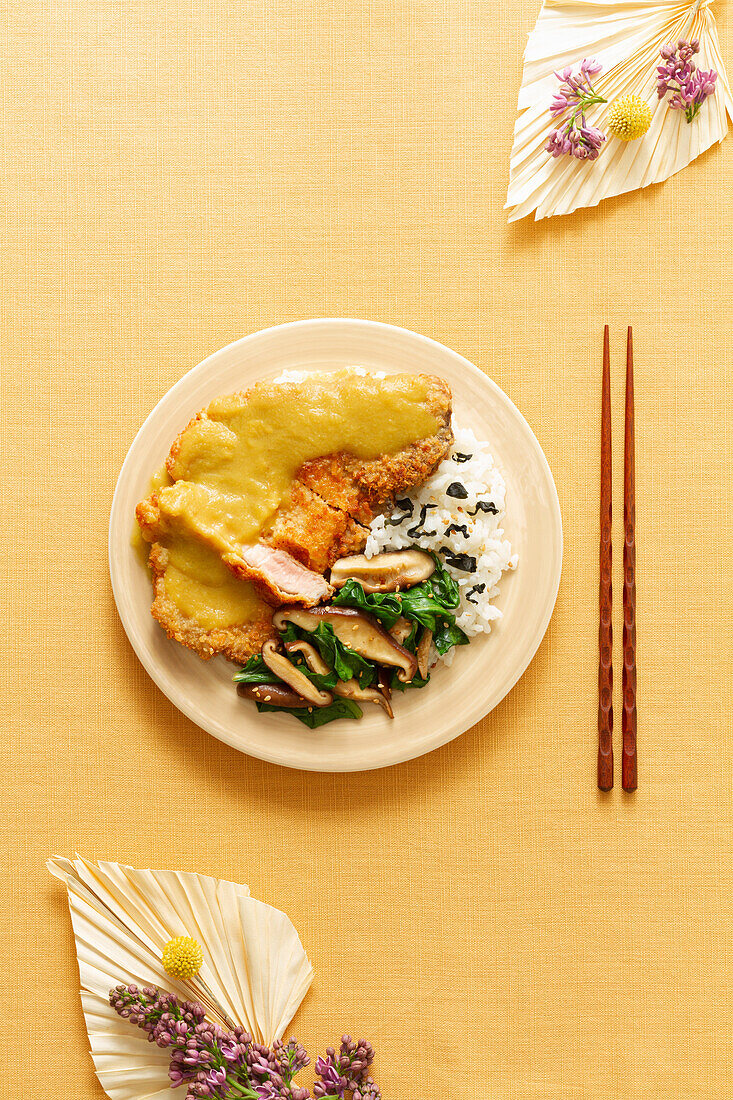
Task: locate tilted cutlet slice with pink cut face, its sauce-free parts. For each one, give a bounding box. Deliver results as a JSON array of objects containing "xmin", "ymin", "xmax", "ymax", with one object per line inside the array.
[{"xmin": 135, "ymin": 484, "xmax": 333, "ymax": 607}]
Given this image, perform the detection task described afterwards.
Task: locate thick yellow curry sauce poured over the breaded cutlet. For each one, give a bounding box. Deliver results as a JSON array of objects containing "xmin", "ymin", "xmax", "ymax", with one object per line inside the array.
[{"xmin": 145, "ymin": 371, "xmax": 437, "ymax": 629}]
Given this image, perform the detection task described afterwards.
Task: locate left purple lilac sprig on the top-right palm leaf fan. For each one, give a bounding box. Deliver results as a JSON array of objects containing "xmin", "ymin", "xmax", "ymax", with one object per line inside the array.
[{"xmin": 545, "ymin": 57, "xmax": 606, "ymax": 161}]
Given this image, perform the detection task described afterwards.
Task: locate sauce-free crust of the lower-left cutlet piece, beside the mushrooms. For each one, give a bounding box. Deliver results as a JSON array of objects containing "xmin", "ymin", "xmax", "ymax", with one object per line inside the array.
[{"xmin": 149, "ymin": 542, "xmax": 276, "ymax": 664}]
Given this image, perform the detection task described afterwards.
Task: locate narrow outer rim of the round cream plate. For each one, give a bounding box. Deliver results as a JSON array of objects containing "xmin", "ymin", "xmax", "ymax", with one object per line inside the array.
[{"xmin": 107, "ymin": 317, "xmax": 565, "ymax": 774}]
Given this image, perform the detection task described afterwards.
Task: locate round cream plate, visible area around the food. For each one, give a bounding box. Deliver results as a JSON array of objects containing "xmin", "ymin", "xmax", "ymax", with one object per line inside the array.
[{"xmin": 109, "ymin": 319, "xmax": 562, "ymax": 771}]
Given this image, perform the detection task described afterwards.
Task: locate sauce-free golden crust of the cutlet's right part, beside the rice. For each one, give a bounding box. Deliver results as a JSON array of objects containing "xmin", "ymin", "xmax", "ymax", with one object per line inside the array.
[{"xmin": 297, "ymin": 374, "xmax": 453, "ymax": 525}]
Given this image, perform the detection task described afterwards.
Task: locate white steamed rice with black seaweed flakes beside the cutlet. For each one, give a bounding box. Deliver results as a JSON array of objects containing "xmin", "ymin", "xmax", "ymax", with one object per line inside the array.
[{"xmin": 365, "ymin": 428, "xmax": 517, "ymax": 663}]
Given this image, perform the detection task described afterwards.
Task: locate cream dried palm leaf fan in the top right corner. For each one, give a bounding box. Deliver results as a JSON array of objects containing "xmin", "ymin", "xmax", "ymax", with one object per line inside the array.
[{"xmin": 506, "ymin": 0, "xmax": 733, "ymax": 221}]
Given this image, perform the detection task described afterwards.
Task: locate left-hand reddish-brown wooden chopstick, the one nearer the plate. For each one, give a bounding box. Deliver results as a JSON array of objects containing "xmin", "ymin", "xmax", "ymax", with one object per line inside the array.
[{"xmin": 598, "ymin": 325, "xmax": 613, "ymax": 791}]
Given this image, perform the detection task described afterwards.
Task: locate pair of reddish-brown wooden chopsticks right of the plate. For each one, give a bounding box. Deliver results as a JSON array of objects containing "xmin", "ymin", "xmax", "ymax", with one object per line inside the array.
[{"xmin": 598, "ymin": 325, "xmax": 636, "ymax": 791}]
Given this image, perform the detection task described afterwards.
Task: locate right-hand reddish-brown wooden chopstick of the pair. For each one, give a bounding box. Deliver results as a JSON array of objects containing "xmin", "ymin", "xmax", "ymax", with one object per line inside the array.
[{"xmin": 621, "ymin": 326, "xmax": 636, "ymax": 791}]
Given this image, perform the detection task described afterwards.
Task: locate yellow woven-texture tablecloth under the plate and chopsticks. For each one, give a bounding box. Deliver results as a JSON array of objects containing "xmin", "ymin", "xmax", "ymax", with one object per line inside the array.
[{"xmin": 0, "ymin": 0, "xmax": 733, "ymax": 1100}]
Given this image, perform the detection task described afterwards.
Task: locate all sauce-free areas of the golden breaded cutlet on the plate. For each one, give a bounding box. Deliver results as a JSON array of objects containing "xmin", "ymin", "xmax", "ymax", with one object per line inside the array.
[{"xmin": 136, "ymin": 375, "xmax": 453, "ymax": 662}]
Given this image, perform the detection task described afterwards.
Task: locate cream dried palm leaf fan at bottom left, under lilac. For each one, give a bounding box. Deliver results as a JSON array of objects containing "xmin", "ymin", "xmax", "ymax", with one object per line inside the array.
[{"xmin": 47, "ymin": 857, "xmax": 314, "ymax": 1100}]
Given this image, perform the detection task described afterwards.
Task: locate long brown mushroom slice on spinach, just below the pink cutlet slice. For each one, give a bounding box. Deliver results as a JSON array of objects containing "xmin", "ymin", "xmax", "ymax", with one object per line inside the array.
[{"xmin": 269, "ymin": 605, "xmax": 417, "ymax": 683}]
